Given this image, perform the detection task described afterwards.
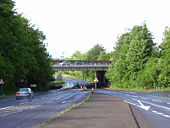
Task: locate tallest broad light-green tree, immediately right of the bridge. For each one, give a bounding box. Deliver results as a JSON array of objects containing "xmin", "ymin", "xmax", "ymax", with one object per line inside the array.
[{"xmin": 106, "ymin": 24, "xmax": 155, "ymax": 88}]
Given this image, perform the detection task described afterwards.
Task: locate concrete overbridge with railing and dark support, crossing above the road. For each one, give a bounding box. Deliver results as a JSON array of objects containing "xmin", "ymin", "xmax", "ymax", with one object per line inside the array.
[{"xmin": 51, "ymin": 60, "xmax": 111, "ymax": 86}]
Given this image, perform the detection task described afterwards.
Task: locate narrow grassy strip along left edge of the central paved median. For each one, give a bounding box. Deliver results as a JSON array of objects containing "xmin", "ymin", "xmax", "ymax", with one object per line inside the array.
[{"xmin": 37, "ymin": 92, "xmax": 92, "ymax": 128}]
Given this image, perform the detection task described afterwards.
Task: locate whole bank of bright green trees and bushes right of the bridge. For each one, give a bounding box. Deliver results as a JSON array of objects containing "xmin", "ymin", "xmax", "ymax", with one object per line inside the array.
[{"xmin": 106, "ymin": 24, "xmax": 170, "ymax": 89}]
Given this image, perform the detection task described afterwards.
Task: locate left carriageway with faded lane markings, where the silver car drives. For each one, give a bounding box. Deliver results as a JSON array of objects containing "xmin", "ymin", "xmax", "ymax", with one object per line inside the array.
[{"xmin": 0, "ymin": 90, "xmax": 89, "ymax": 128}]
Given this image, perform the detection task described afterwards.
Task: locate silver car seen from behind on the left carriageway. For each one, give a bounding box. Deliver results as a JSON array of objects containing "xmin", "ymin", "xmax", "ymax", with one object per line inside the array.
[{"xmin": 16, "ymin": 88, "xmax": 33, "ymax": 100}]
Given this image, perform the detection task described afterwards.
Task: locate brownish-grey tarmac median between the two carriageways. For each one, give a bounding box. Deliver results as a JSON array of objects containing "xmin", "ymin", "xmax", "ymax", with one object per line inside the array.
[{"xmin": 41, "ymin": 93, "xmax": 147, "ymax": 128}]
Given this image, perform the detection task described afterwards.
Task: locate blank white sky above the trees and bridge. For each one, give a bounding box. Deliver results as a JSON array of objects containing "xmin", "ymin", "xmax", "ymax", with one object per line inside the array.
[{"xmin": 14, "ymin": 0, "xmax": 170, "ymax": 58}]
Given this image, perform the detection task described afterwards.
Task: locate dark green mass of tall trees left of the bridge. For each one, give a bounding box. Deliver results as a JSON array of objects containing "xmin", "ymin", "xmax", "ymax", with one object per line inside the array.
[{"xmin": 0, "ymin": 0, "xmax": 53, "ymax": 93}]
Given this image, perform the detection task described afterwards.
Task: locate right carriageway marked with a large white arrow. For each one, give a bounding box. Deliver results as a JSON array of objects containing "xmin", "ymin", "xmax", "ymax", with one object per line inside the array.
[{"xmin": 97, "ymin": 90, "xmax": 170, "ymax": 128}]
